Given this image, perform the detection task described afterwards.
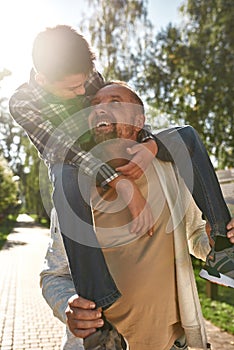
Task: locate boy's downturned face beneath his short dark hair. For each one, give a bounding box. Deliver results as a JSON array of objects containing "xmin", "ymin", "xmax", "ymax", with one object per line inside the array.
[{"xmin": 40, "ymin": 74, "xmax": 87, "ymax": 100}]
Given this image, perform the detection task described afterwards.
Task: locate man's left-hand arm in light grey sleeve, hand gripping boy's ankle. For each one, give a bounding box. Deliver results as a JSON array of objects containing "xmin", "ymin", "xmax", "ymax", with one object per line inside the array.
[{"xmin": 40, "ymin": 209, "xmax": 103, "ymax": 340}]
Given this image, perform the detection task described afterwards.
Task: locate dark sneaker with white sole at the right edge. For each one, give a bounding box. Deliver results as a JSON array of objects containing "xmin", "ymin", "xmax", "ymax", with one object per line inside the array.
[{"xmin": 199, "ymin": 247, "xmax": 234, "ymax": 288}]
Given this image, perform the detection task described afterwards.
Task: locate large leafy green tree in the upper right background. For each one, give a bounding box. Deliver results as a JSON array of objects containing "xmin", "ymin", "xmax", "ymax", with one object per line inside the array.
[{"xmin": 144, "ymin": 0, "xmax": 234, "ymax": 168}]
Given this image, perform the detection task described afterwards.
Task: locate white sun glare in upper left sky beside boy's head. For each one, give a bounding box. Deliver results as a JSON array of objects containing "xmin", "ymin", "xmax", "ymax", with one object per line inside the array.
[{"xmin": 0, "ymin": 0, "xmax": 82, "ymax": 96}]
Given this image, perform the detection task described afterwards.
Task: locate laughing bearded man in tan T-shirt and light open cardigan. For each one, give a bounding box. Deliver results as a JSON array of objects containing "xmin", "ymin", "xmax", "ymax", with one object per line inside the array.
[{"xmin": 41, "ymin": 84, "xmax": 218, "ymax": 350}]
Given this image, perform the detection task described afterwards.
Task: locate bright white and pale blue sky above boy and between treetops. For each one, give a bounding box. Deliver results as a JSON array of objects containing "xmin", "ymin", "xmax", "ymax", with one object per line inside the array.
[{"xmin": 0, "ymin": 0, "xmax": 182, "ymax": 97}]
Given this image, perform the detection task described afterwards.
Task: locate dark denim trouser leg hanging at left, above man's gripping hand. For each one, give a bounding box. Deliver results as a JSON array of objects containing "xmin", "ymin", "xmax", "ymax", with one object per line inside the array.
[{"xmin": 51, "ymin": 164, "xmax": 120, "ymax": 309}]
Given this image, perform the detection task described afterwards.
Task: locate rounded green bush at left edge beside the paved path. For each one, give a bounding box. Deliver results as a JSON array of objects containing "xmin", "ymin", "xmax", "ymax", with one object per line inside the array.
[{"xmin": 0, "ymin": 157, "xmax": 18, "ymax": 217}]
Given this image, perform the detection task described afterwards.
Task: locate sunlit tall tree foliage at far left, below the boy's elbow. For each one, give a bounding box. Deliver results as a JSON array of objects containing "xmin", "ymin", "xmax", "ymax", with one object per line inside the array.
[{"xmin": 0, "ymin": 70, "xmax": 51, "ymax": 220}]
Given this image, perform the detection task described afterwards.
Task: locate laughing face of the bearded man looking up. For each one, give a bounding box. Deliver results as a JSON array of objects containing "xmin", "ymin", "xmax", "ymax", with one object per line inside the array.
[{"xmin": 89, "ymin": 84, "xmax": 144, "ymax": 143}]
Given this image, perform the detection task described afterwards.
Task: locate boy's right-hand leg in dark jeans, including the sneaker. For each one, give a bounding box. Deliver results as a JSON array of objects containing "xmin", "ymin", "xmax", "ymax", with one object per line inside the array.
[{"xmin": 156, "ymin": 126, "xmax": 234, "ymax": 287}]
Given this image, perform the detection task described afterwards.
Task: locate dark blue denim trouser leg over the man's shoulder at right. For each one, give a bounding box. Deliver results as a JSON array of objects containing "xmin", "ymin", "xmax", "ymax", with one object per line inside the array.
[{"xmin": 155, "ymin": 126, "xmax": 231, "ymax": 238}]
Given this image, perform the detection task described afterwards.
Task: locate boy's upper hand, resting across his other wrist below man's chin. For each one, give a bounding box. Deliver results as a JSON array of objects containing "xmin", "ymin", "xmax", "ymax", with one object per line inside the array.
[{"xmin": 116, "ymin": 140, "xmax": 158, "ymax": 180}]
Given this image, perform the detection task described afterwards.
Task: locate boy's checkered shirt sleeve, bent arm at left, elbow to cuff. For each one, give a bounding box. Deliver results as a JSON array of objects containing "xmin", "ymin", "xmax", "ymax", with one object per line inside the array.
[{"xmin": 9, "ymin": 90, "xmax": 118, "ymax": 184}]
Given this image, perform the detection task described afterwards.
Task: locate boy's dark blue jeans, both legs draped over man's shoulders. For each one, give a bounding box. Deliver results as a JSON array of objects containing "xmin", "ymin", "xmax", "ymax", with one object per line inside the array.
[{"xmin": 51, "ymin": 126, "xmax": 230, "ymax": 309}]
